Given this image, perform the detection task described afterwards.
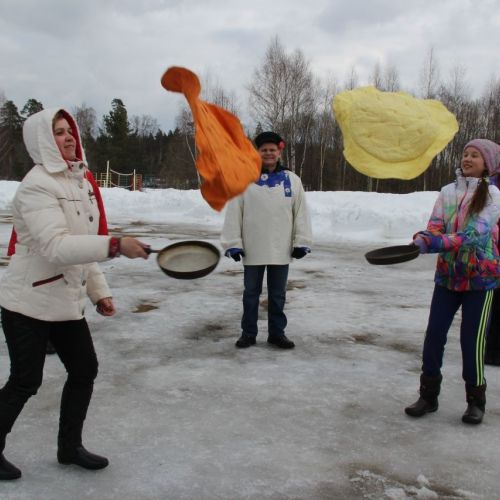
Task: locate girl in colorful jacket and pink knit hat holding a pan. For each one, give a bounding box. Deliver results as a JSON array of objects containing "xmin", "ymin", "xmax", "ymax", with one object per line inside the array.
[{"xmin": 405, "ymin": 139, "xmax": 500, "ymax": 424}]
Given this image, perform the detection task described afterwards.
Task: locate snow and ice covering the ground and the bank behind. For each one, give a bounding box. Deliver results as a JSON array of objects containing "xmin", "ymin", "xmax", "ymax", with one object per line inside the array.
[{"xmin": 0, "ymin": 181, "xmax": 500, "ymax": 500}]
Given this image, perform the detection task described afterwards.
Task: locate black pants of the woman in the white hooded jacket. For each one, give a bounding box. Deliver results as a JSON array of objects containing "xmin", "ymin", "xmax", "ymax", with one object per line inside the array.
[{"xmin": 0, "ymin": 308, "xmax": 98, "ymax": 448}]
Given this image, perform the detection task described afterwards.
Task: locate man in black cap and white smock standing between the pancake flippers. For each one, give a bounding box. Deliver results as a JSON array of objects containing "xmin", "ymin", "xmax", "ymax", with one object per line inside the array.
[{"xmin": 221, "ymin": 132, "xmax": 312, "ymax": 349}]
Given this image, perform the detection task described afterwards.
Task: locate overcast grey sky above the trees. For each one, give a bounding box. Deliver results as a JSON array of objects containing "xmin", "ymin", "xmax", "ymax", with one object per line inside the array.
[{"xmin": 0, "ymin": 0, "xmax": 500, "ymax": 131}]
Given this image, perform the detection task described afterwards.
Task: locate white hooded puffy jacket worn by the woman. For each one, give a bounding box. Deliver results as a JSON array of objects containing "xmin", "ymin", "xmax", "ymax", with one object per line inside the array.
[{"xmin": 0, "ymin": 109, "xmax": 111, "ymax": 321}]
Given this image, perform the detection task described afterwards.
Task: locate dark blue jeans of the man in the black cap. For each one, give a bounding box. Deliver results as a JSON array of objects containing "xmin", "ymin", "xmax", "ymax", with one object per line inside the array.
[{"xmin": 241, "ymin": 264, "xmax": 288, "ymax": 337}]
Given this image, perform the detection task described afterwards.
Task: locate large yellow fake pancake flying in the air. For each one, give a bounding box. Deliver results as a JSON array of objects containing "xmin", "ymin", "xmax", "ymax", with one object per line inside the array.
[{"xmin": 333, "ymin": 87, "xmax": 458, "ymax": 180}]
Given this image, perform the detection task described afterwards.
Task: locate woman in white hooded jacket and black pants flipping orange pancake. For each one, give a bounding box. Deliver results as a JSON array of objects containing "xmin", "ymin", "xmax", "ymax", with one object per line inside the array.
[{"xmin": 0, "ymin": 109, "xmax": 148, "ymax": 480}]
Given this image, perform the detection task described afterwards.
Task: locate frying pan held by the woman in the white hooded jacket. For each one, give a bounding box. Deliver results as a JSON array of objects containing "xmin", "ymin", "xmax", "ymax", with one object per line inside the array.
[{"xmin": 146, "ymin": 240, "xmax": 220, "ymax": 280}]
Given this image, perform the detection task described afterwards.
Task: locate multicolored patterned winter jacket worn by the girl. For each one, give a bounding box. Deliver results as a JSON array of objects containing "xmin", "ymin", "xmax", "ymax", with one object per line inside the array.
[{"xmin": 417, "ymin": 170, "xmax": 500, "ymax": 292}]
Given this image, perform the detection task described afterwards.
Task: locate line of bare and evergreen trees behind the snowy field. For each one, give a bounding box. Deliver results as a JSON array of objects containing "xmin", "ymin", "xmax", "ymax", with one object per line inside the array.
[{"xmin": 0, "ymin": 37, "xmax": 500, "ymax": 193}]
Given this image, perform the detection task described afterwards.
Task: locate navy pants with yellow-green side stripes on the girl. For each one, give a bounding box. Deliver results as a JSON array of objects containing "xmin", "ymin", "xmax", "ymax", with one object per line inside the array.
[{"xmin": 422, "ymin": 285, "xmax": 493, "ymax": 386}]
